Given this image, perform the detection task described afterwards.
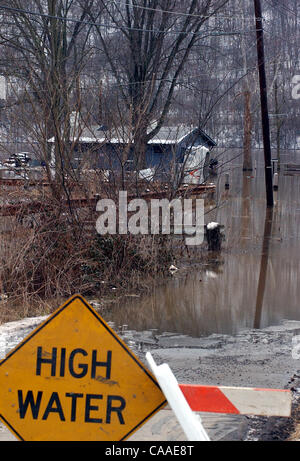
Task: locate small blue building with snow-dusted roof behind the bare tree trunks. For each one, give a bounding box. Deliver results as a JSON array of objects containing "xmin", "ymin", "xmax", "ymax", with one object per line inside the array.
[{"xmin": 49, "ymin": 125, "xmax": 216, "ymax": 184}]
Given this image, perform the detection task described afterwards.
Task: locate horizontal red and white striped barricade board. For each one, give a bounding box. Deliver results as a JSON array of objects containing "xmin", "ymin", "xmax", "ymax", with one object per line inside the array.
[{"xmin": 179, "ymin": 384, "xmax": 292, "ymax": 417}]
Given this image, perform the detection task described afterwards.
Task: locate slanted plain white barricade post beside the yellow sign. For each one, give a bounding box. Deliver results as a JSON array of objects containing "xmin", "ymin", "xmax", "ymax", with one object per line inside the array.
[{"xmin": 146, "ymin": 352, "xmax": 210, "ymax": 442}]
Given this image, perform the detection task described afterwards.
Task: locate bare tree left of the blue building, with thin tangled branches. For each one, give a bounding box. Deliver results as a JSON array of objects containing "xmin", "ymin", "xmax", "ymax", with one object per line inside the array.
[{"xmin": 0, "ymin": 0, "xmax": 92, "ymax": 197}]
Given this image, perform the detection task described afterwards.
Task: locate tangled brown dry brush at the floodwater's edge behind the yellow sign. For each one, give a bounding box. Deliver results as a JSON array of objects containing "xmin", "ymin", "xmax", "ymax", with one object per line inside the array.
[{"xmin": 0, "ymin": 199, "xmax": 172, "ymax": 321}]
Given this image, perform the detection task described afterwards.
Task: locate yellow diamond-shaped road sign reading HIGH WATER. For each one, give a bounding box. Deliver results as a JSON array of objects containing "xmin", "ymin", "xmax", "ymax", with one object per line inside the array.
[{"xmin": 0, "ymin": 295, "xmax": 166, "ymax": 441}]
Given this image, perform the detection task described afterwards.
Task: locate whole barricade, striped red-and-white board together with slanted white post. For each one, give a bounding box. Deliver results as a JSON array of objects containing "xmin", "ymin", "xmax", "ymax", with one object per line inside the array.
[{"xmin": 146, "ymin": 352, "xmax": 292, "ymax": 441}]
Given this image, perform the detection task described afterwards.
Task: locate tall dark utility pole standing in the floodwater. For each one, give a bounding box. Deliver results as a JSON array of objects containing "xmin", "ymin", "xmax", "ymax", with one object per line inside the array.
[{"xmin": 254, "ymin": 0, "xmax": 274, "ymax": 207}]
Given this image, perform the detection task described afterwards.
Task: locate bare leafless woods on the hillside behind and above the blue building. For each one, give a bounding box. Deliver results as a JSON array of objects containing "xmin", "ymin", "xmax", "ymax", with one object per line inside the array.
[{"xmin": 0, "ymin": 0, "xmax": 299, "ymax": 181}]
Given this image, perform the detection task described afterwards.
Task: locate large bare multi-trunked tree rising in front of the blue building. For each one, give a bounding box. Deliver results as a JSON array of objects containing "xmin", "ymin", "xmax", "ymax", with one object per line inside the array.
[{"xmin": 90, "ymin": 0, "xmax": 228, "ymax": 169}]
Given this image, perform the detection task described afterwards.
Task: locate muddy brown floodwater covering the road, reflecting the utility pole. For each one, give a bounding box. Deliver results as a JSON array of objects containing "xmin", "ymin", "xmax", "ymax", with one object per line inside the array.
[{"xmin": 105, "ymin": 151, "xmax": 300, "ymax": 337}]
